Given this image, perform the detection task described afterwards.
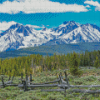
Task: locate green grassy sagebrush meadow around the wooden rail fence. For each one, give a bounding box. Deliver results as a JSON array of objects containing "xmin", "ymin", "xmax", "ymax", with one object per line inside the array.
[{"xmin": 0, "ymin": 68, "xmax": 100, "ymax": 100}]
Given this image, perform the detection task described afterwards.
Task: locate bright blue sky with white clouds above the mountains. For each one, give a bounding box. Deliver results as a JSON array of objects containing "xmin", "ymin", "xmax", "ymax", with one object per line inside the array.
[{"xmin": 0, "ymin": 0, "xmax": 100, "ymax": 30}]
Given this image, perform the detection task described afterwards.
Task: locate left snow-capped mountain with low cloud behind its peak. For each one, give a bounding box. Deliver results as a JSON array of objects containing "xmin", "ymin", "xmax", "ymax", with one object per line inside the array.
[{"xmin": 0, "ymin": 23, "xmax": 57, "ymax": 51}]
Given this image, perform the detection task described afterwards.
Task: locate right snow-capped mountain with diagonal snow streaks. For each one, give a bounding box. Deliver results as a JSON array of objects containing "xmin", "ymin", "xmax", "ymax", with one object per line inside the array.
[{"xmin": 45, "ymin": 21, "xmax": 100, "ymax": 45}]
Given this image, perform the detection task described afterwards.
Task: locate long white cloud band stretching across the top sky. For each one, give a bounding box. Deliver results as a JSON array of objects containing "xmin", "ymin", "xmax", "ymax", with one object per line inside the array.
[{"xmin": 0, "ymin": 0, "xmax": 88, "ymax": 14}]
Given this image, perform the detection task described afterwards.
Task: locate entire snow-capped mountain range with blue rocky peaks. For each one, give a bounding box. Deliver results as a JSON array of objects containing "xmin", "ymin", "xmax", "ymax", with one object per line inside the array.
[{"xmin": 0, "ymin": 21, "xmax": 100, "ymax": 51}]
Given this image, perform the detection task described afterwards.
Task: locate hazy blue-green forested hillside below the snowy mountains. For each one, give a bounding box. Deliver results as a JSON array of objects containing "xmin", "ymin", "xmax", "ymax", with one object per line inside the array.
[{"xmin": 0, "ymin": 42, "xmax": 100, "ymax": 58}]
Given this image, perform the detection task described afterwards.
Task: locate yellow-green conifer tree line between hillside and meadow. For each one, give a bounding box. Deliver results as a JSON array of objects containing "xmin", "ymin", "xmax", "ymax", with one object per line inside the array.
[{"xmin": 0, "ymin": 50, "xmax": 100, "ymax": 76}]
